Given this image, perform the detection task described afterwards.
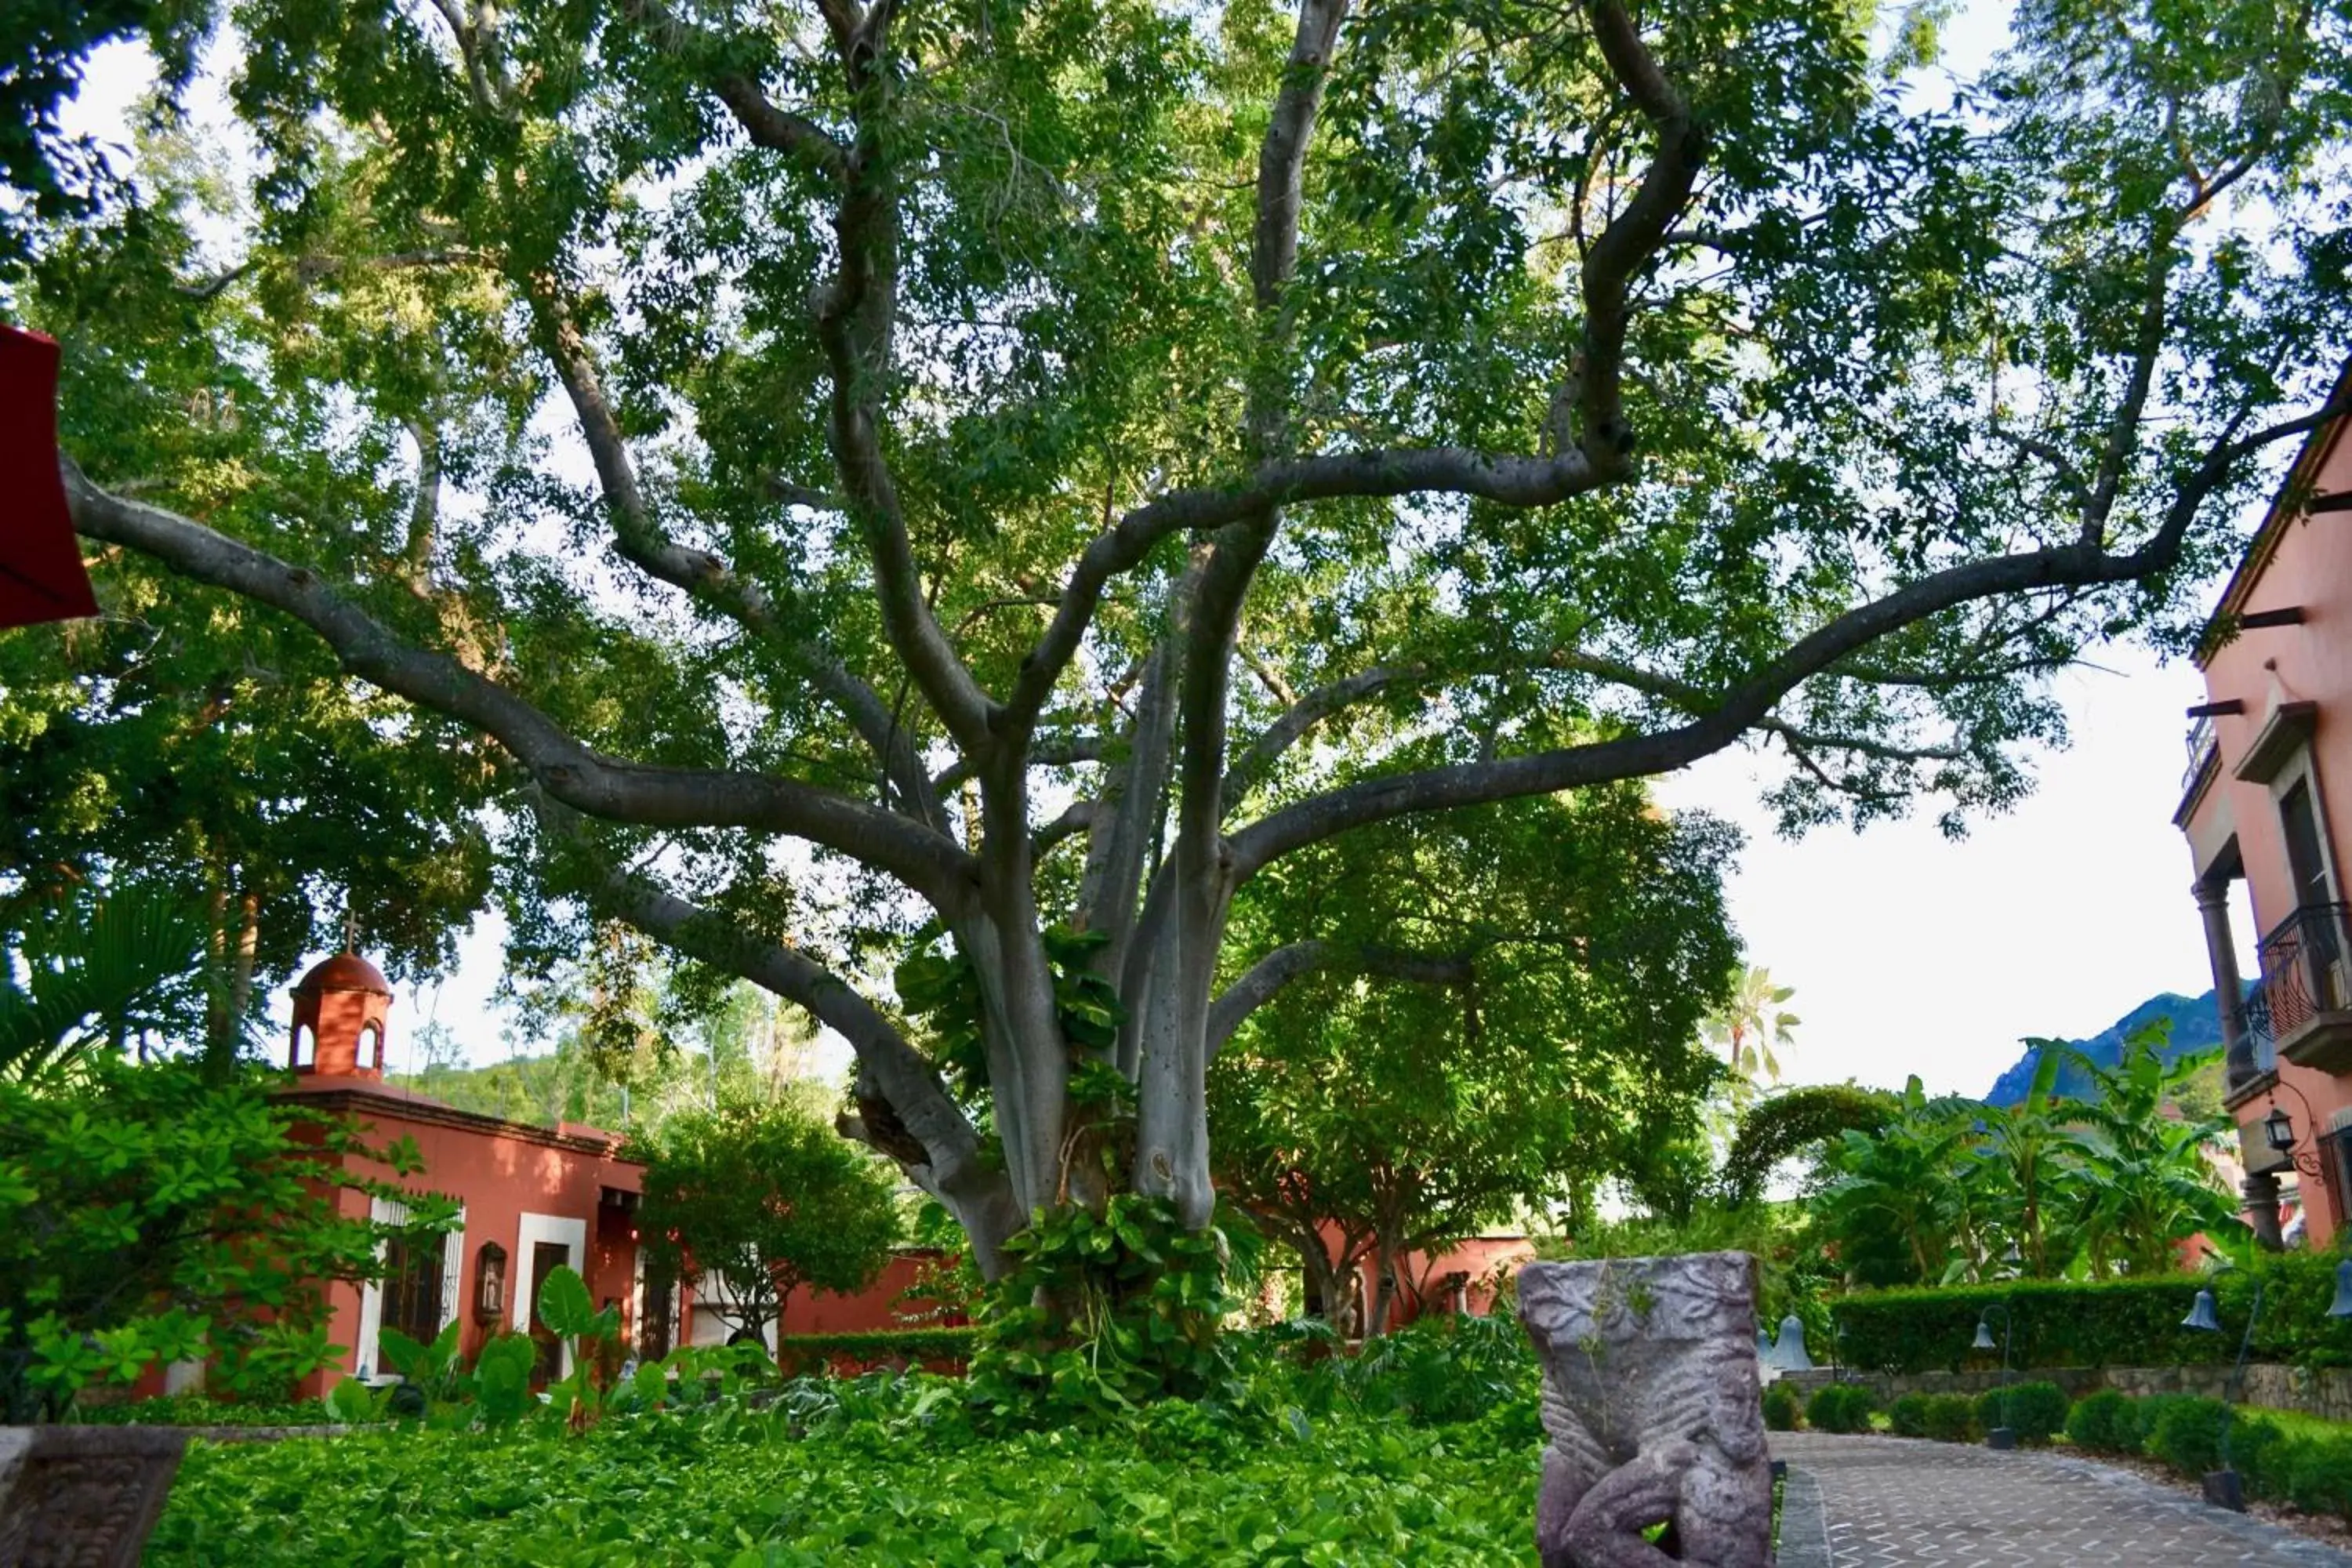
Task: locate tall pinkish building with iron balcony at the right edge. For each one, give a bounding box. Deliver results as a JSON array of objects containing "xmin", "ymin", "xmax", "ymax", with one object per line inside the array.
[{"xmin": 2173, "ymin": 362, "xmax": 2352, "ymax": 1243}]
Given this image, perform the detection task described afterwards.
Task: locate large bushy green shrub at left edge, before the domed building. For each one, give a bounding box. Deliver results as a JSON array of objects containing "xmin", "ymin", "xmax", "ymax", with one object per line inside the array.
[{"xmin": 0, "ymin": 1051, "xmax": 456, "ymax": 1422}]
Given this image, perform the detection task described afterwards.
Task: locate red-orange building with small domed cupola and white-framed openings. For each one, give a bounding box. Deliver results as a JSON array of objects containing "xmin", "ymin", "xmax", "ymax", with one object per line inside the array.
[{"xmin": 280, "ymin": 952, "xmax": 659, "ymax": 1394}]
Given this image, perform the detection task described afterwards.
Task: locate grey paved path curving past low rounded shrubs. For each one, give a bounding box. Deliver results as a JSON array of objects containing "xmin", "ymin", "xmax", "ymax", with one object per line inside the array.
[{"xmin": 1771, "ymin": 1432, "xmax": 2352, "ymax": 1568}]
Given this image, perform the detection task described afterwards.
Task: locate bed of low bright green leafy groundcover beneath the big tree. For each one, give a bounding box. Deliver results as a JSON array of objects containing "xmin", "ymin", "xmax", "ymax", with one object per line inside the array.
[{"xmin": 146, "ymin": 1406, "xmax": 1538, "ymax": 1568}]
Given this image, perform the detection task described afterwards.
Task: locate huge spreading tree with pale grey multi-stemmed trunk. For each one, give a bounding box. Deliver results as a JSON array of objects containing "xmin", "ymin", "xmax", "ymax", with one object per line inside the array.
[{"xmin": 26, "ymin": 0, "xmax": 2352, "ymax": 1269}]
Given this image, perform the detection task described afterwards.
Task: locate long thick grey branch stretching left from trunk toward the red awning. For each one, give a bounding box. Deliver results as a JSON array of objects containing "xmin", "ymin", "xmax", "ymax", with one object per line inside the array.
[{"xmin": 61, "ymin": 459, "xmax": 974, "ymax": 909}]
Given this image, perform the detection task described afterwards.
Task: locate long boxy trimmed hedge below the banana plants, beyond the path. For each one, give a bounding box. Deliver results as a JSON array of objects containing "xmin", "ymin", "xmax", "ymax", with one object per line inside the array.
[{"xmin": 1830, "ymin": 1253, "xmax": 2352, "ymax": 1373}]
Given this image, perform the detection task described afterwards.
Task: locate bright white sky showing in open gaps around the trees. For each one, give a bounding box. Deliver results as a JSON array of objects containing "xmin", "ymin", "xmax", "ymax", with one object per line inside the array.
[{"xmin": 68, "ymin": 0, "xmax": 2251, "ymax": 1093}]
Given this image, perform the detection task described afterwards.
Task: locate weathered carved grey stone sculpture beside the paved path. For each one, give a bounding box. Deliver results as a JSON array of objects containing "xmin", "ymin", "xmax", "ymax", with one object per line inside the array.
[{"xmin": 1519, "ymin": 1253, "xmax": 1771, "ymax": 1568}]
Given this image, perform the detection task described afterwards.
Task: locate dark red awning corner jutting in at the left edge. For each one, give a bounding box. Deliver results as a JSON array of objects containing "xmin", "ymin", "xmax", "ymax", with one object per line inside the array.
[{"xmin": 0, "ymin": 325, "xmax": 99, "ymax": 628}]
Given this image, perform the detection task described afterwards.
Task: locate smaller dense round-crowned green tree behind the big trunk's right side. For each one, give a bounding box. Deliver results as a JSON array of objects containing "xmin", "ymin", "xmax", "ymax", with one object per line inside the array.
[{"xmin": 1209, "ymin": 785, "xmax": 1736, "ymax": 1333}]
